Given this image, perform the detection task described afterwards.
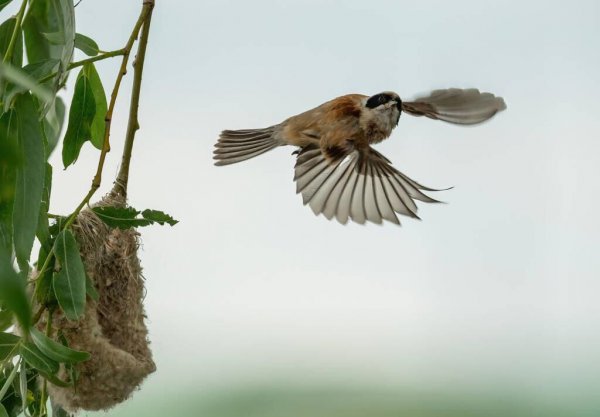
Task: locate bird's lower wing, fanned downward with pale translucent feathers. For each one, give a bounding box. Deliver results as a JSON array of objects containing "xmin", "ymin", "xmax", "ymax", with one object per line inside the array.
[{"xmin": 294, "ymin": 145, "xmax": 438, "ymax": 224}]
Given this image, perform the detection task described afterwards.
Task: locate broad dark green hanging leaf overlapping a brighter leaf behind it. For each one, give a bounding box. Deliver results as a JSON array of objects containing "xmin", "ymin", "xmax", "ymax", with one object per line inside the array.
[{"xmin": 62, "ymin": 69, "xmax": 96, "ymax": 168}]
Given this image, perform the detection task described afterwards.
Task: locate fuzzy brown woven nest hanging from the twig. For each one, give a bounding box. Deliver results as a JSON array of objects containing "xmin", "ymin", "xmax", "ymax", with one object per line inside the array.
[{"xmin": 48, "ymin": 193, "xmax": 156, "ymax": 412}]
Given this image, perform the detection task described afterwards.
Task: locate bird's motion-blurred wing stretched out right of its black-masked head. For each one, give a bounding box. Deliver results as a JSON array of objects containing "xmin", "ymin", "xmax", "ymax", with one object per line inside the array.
[{"xmin": 402, "ymin": 88, "xmax": 506, "ymax": 125}]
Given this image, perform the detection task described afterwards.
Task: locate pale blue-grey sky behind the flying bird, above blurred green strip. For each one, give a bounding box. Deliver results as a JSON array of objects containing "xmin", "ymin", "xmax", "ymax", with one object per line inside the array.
[{"xmin": 8, "ymin": 0, "xmax": 600, "ymax": 415}]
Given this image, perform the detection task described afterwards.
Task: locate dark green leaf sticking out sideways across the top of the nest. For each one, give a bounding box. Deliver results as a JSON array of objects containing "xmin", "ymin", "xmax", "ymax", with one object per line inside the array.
[{"xmin": 92, "ymin": 206, "xmax": 178, "ymax": 229}]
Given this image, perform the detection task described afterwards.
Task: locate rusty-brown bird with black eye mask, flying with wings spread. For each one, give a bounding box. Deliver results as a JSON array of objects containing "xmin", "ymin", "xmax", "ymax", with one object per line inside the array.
[{"xmin": 213, "ymin": 88, "xmax": 506, "ymax": 225}]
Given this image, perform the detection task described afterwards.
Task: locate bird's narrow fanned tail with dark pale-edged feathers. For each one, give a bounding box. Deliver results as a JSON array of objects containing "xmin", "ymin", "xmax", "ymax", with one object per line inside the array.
[{"xmin": 213, "ymin": 126, "xmax": 281, "ymax": 165}]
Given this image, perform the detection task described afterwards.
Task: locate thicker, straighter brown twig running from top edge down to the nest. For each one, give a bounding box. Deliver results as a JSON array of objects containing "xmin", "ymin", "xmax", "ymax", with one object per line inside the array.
[{"xmin": 113, "ymin": 0, "xmax": 154, "ymax": 197}]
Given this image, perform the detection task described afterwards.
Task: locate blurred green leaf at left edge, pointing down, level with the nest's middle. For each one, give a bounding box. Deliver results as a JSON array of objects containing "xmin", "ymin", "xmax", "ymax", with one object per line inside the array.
[{"xmin": 0, "ymin": 245, "xmax": 31, "ymax": 331}]
